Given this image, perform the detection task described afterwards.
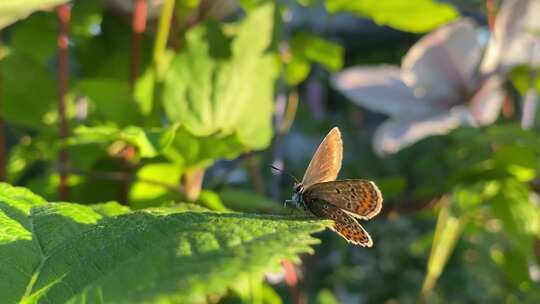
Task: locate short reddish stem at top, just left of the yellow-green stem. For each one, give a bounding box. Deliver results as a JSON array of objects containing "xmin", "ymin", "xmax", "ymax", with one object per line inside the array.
[{"xmin": 129, "ymin": 0, "xmax": 148, "ymax": 90}]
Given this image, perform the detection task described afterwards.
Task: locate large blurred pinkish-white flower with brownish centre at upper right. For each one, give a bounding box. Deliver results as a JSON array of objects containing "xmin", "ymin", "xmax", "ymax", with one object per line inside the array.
[{"xmin": 332, "ymin": 0, "xmax": 540, "ymax": 156}]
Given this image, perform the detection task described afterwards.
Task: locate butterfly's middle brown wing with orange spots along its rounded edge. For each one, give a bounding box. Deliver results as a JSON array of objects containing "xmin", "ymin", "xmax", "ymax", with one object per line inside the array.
[{"xmin": 303, "ymin": 179, "xmax": 383, "ymax": 220}]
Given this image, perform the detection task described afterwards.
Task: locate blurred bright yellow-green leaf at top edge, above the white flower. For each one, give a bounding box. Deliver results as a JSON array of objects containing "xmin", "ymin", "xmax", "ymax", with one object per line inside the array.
[{"xmin": 326, "ymin": 0, "xmax": 459, "ymax": 33}]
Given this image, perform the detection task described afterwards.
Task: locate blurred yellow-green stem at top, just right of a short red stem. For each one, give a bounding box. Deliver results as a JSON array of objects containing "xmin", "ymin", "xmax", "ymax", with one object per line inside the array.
[{"xmin": 153, "ymin": 0, "xmax": 174, "ymax": 79}]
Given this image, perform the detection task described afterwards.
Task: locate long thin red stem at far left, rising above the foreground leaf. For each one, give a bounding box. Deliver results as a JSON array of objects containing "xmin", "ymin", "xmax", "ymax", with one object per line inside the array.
[{"xmin": 56, "ymin": 4, "xmax": 71, "ymax": 200}]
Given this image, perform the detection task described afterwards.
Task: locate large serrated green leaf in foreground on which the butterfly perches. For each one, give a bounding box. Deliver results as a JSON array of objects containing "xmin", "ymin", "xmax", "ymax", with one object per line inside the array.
[{"xmin": 0, "ymin": 184, "xmax": 327, "ymax": 303}]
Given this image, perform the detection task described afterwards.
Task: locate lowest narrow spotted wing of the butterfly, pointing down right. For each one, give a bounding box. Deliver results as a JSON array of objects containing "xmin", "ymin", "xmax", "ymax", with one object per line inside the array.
[{"xmin": 306, "ymin": 199, "xmax": 373, "ymax": 247}]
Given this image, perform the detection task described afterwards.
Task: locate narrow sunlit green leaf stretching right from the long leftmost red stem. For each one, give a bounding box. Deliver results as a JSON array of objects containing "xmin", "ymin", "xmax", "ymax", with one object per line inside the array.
[{"xmin": 69, "ymin": 125, "xmax": 176, "ymax": 157}]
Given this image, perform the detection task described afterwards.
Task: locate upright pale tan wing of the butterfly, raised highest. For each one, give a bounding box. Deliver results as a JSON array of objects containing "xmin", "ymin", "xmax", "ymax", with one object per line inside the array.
[{"xmin": 302, "ymin": 127, "xmax": 343, "ymax": 189}]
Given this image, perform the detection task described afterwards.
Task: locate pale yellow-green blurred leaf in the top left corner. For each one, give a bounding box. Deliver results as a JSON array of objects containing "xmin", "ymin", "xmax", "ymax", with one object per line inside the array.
[{"xmin": 0, "ymin": 0, "xmax": 68, "ymax": 29}]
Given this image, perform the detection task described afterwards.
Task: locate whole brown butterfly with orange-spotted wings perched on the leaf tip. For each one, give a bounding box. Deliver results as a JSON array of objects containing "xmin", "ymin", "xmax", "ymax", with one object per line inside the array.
[{"xmin": 286, "ymin": 127, "xmax": 383, "ymax": 247}]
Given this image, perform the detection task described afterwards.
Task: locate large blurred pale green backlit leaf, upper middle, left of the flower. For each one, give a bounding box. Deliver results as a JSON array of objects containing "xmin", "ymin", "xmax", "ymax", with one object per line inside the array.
[{"xmin": 163, "ymin": 4, "xmax": 277, "ymax": 149}]
